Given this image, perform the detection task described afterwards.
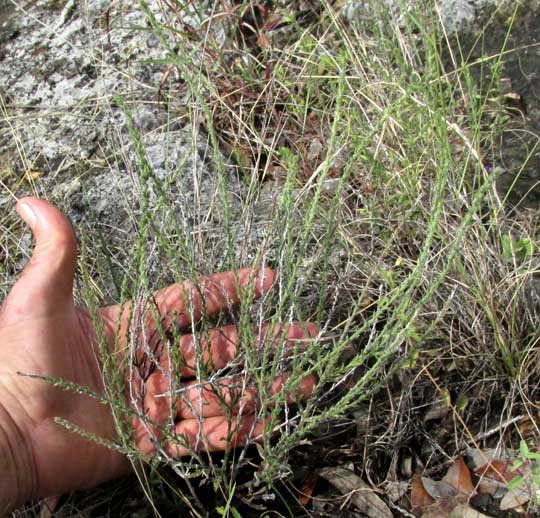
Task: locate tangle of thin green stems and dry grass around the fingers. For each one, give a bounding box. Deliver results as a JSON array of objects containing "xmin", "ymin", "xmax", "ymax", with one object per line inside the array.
[{"xmin": 4, "ymin": 0, "xmax": 540, "ymax": 516}]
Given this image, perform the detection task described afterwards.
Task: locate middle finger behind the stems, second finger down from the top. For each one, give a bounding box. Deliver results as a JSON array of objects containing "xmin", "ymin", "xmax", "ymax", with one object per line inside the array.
[{"xmin": 160, "ymin": 322, "xmax": 319, "ymax": 378}]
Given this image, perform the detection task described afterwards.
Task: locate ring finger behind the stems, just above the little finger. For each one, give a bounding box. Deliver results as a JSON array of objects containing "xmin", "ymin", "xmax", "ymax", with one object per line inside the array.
[{"xmin": 175, "ymin": 373, "xmax": 316, "ymax": 419}]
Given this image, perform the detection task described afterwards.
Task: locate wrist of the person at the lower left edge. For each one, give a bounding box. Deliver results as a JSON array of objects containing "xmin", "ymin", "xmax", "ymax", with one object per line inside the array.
[{"xmin": 0, "ymin": 402, "xmax": 36, "ymax": 512}]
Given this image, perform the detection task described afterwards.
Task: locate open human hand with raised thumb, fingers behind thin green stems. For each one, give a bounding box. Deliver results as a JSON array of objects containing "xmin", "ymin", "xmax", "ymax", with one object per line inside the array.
[{"xmin": 0, "ymin": 198, "xmax": 317, "ymax": 509}]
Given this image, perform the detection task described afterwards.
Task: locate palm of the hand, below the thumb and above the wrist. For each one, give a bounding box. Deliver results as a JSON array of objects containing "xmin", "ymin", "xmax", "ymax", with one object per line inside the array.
[{"xmin": 0, "ymin": 256, "xmax": 127, "ymax": 496}]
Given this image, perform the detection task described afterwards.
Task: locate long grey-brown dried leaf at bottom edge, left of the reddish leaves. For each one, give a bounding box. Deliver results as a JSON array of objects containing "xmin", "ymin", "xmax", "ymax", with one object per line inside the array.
[{"xmin": 319, "ymin": 466, "xmax": 392, "ymax": 518}]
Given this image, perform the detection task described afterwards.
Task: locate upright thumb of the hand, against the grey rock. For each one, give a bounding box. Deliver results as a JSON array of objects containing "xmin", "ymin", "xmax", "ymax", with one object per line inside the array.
[{"xmin": 9, "ymin": 198, "xmax": 77, "ymax": 309}]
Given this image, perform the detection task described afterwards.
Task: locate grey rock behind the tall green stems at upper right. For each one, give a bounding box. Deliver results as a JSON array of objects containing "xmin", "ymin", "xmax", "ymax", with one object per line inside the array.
[{"xmin": 344, "ymin": 0, "xmax": 540, "ymax": 207}]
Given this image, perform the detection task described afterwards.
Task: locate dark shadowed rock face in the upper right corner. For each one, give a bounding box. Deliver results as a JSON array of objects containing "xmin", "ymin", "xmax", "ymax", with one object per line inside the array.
[{"xmin": 459, "ymin": 0, "xmax": 540, "ymax": 208}]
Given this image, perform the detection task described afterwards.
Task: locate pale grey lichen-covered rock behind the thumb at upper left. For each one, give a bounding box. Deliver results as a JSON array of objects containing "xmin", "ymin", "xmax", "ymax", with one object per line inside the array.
[{"xmin": 0, "ymin": 0, "xmax": 255, "ymax": 298}]
